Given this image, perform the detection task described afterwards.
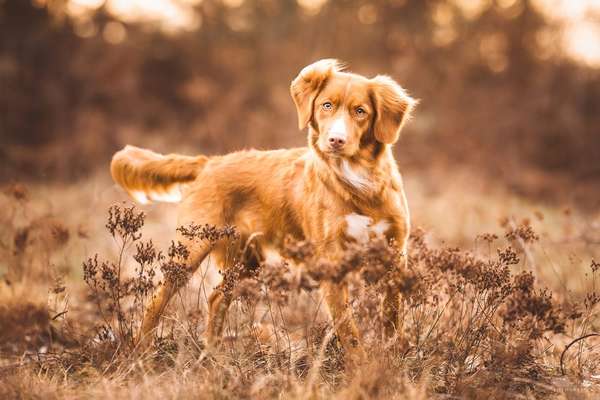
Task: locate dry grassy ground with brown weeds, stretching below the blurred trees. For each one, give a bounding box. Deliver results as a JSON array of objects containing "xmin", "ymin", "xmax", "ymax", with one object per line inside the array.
[{"xmin": 0, "ymin": 172, "xmax": 600, "ymax": 399}]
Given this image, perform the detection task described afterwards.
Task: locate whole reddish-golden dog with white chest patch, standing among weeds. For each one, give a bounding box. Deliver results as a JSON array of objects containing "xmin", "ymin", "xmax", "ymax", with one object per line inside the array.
[{"xmin": 111, "ymin": 59, "xmax": 415, "ymax": 361}]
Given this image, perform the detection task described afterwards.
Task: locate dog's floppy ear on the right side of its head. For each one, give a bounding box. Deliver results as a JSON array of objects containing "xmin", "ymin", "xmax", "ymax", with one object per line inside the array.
[{"xmin": 371, "ymin": 75, "xmax": 417, "ymax": 144}]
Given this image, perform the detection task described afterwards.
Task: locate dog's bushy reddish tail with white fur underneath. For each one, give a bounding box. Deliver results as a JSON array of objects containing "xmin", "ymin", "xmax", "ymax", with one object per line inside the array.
[{"xmin": 110, "ymin": 145, "xmax": 208, "ymax": 204}]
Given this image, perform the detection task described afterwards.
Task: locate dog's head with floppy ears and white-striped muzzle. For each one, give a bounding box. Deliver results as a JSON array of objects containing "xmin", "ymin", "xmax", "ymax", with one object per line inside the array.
[{"xmin": 290, "ymin": 59, "xmax": 416, "ymax": 157}]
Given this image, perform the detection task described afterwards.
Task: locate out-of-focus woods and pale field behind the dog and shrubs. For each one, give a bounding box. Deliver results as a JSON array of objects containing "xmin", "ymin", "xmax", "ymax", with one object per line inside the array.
[{"xmin": 0, "ymin": 0, "xmax": 600, "ymax": 338}]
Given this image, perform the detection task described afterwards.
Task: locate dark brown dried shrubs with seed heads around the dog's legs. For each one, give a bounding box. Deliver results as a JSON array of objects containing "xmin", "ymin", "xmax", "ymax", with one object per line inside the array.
[{"xmin": 0, "ymin": 206, "xmax": 598, "ymax": 399}]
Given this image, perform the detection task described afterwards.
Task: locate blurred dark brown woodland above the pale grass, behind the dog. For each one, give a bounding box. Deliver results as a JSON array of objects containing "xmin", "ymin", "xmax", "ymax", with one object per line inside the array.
[{"xmin": 0, "ymin": 0, "xmax": 600, "ymax": 209}]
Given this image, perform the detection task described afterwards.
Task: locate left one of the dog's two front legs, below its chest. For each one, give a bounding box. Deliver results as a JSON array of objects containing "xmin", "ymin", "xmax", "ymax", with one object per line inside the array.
[{"xmin": 321, "ymin": 282, "xmax": 365, "ymax": 367}]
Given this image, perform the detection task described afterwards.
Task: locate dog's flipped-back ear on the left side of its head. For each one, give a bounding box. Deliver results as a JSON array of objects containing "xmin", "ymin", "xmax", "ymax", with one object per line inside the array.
[{"xmin": 290, "ymin": 58, "xmax": 343, "ymax": 129}]
